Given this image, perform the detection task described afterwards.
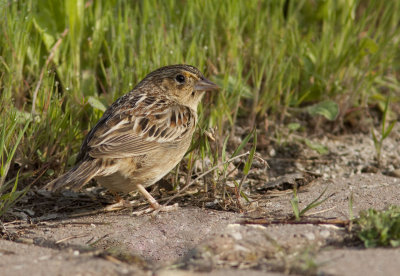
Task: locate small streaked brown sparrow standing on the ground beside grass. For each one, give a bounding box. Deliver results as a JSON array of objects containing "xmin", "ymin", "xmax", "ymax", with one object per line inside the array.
[{"xmin": 45, "ymin": 64, "xmax": 219, "ymax": 210}]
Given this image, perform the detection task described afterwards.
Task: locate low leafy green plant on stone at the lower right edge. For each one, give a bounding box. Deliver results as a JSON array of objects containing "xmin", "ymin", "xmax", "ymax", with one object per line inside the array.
[{"xmin": 356, "ymin": 206, "xmax": 400, "ymax": 248}]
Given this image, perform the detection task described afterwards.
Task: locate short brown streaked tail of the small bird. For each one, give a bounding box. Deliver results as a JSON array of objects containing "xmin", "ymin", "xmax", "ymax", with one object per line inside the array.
[{"xmin": 45, "ymin": 160, "xmax": 100, "ymax": 191}]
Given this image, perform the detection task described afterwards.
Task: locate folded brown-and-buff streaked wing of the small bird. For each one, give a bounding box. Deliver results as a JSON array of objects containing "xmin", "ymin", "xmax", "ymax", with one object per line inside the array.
[{"xmin": 81, "ymin": 96, "xmax": 196, "ymax": 158}]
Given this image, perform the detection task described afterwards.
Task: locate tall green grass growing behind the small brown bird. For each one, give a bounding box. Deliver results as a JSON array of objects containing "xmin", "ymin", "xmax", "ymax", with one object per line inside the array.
[{"xmin": 0, "ymin": 0, "xmax": 400, "ymax": 215}]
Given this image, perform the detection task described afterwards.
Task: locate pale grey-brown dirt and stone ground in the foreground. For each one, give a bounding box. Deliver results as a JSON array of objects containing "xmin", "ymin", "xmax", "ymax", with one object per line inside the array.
[{"xmin": 0, "ymin": 129, "xmax": 400, "ymax": 276}]
